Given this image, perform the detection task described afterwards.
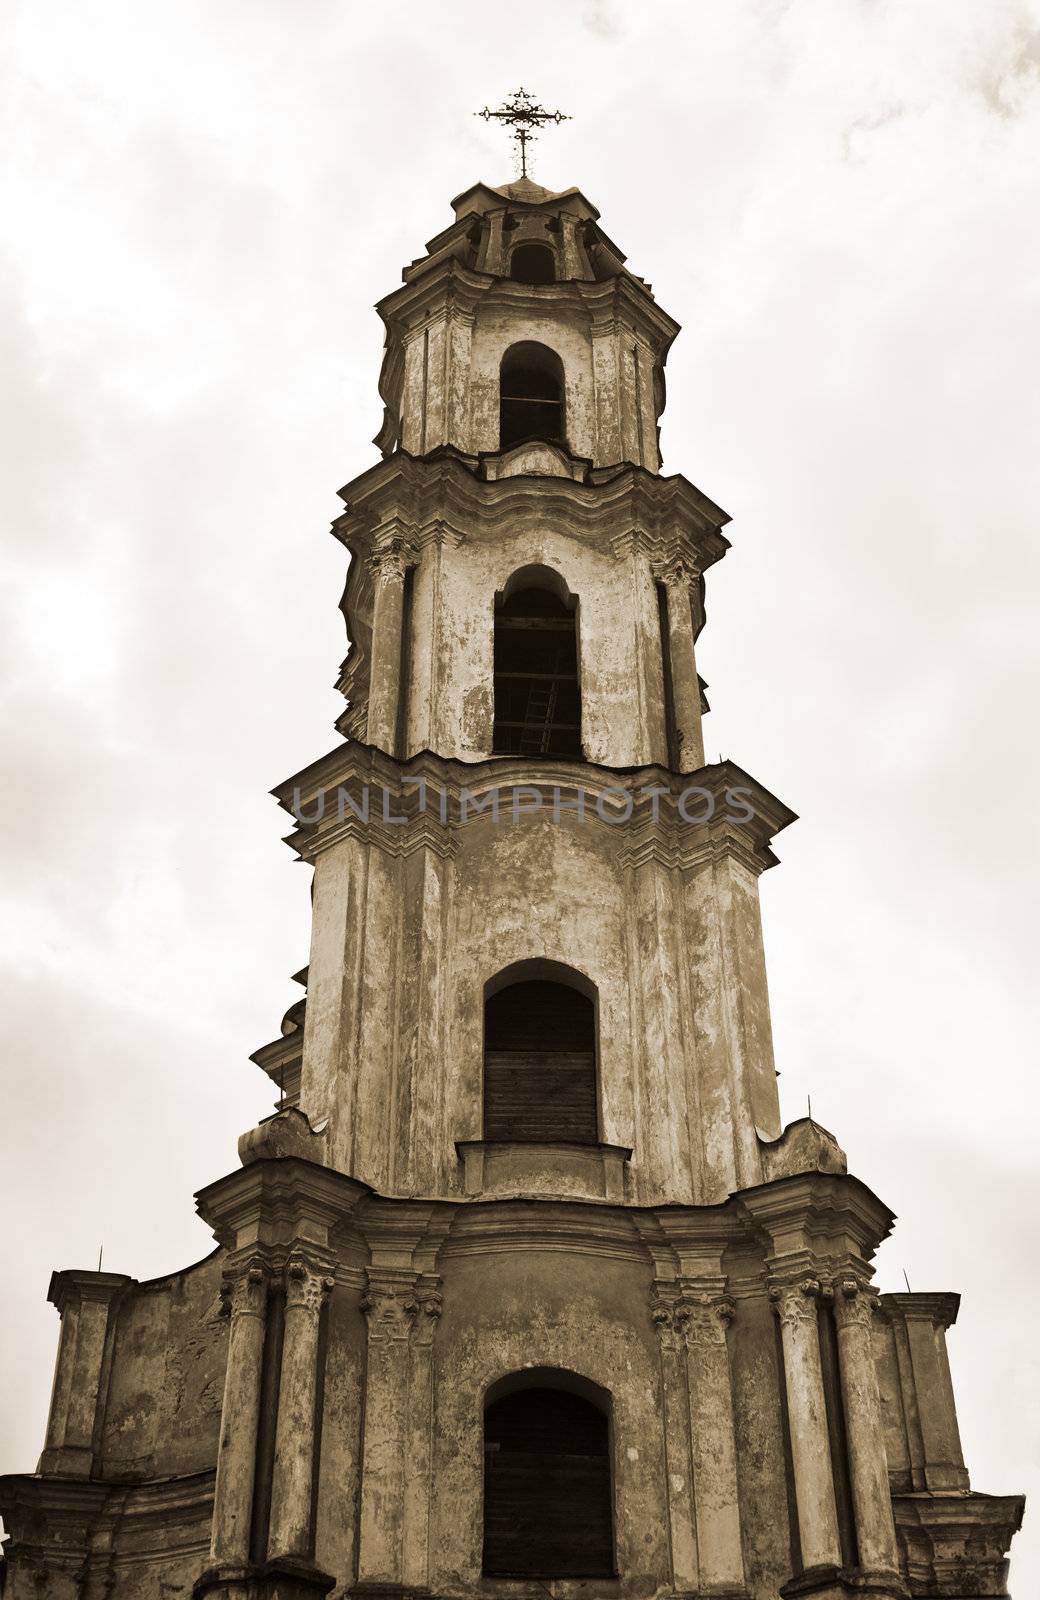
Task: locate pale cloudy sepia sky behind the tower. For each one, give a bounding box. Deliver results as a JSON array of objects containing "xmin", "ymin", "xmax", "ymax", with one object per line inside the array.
[{"xmin": 0, "ymin": 0, "xmax": 1040, "ymax": 1597}]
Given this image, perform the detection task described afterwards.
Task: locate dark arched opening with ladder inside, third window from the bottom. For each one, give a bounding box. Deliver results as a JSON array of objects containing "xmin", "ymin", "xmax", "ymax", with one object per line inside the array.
[{"xmin": 491, "ymin": 566, "xmax": 581, "ymax": 755}]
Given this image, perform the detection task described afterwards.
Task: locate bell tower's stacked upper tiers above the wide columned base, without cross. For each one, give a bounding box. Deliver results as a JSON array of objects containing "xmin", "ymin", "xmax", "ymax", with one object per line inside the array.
[{"xmin": 277, "ymin": 168, "xmax": 780, "ymax": 1205}]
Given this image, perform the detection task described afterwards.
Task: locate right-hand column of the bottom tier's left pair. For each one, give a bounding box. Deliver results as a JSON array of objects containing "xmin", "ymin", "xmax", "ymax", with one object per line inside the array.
[{"xmin": 267, "ymin": 1256, "xmax": 334, "ymax": 1558}]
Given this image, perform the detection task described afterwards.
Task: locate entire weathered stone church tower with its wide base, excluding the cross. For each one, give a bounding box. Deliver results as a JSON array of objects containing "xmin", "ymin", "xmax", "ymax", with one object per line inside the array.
[{"xmin": 0, "ymin": 181, "xmax": 1022, "ymax": 1600}]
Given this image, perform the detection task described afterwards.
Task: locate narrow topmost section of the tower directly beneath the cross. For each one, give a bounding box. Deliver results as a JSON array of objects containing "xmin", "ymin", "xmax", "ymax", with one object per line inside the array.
[{"xmin": 376, "ymin": 178, "xmax": 678, "ymax": 482}]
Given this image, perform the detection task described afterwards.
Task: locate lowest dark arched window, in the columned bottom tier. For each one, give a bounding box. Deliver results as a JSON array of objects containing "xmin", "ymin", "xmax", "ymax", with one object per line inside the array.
[{"xmin": 483, "ymin": 1368, "xmax": 614, "ymax": 1578}]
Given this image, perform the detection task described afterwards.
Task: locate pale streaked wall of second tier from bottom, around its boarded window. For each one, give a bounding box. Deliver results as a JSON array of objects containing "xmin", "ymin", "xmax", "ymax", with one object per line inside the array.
[{"xmin": 289, "ymin": 763, "xmax": 779, "ymax": 1203}]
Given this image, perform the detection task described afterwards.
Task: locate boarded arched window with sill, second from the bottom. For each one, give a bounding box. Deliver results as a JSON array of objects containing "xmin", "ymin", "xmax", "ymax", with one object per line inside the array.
[{"xmin": 483, "ymin": 963, "xmax": 598, "ymax": 1144}]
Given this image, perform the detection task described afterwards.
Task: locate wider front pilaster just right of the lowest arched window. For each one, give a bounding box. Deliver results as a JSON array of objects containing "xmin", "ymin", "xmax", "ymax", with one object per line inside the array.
[{"xmin": 678, "ymin": 1293, "xmax": 744, "ymax": 1589}]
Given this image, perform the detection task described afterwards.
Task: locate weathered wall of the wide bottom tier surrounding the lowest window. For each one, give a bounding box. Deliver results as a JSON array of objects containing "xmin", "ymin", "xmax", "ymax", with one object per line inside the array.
[{"xmin": 3, "ymin": 1164, "xmax": 1021, "ymax": 1600}]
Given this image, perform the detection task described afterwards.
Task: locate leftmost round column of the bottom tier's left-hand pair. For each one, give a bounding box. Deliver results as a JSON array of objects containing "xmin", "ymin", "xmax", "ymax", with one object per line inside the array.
[{"xmin": 210, "ymin": 1258, "xmax": 267, "ymax": 1565}]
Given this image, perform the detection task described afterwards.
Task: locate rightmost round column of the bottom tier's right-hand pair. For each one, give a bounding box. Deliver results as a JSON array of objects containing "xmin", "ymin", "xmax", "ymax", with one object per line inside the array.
[{"xmin": 834, "ymin": 1278, "xmax": 899, "ymax": 1573}]
